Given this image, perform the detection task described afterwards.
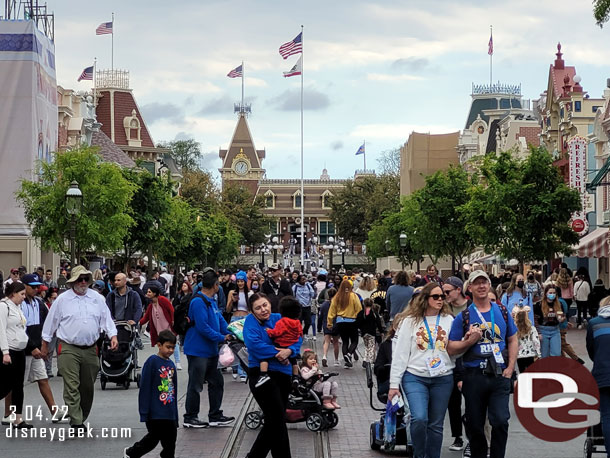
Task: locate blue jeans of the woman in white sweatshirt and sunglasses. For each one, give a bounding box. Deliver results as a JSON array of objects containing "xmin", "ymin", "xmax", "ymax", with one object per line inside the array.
[{"xmin": 402, "ymin": 372, "xmax": 453, "ymax": 458}]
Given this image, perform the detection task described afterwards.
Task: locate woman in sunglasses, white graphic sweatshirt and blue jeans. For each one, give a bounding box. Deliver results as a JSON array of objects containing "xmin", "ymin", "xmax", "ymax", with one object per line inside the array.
[{"xmin": 388, "ymin": 282, "xmax": 455, "ymax": 458}]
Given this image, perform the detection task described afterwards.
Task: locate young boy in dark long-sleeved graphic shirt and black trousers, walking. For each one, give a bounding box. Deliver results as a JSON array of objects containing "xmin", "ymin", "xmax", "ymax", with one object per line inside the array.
[{"xmin": 124, "ymin": 329, "xmax": 178, "ymax": 458}]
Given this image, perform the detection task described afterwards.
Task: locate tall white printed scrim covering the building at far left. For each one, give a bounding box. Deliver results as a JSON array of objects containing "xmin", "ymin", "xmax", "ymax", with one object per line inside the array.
[{"xmin": 0, "ymin": 20, "xmax": 57, "ymax": 235}]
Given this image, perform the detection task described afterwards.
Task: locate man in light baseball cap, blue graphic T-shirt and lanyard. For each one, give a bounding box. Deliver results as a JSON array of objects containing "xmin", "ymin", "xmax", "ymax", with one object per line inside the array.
[{"xmin": 447, "ymin": 270, "xmax": 518, "ymax": 458}]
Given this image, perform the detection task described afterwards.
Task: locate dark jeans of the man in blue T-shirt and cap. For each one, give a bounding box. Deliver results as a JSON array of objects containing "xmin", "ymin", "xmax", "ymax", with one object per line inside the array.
[{"xmin": 462, "ymin": 368, "xmax": 512, "ymax": 458}]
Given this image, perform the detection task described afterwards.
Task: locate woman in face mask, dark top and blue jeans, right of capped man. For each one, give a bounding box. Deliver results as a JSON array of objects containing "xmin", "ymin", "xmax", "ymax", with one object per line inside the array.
[{"xmin": 534, "ymin": 285, "xmax": 566, "ymax": 358}]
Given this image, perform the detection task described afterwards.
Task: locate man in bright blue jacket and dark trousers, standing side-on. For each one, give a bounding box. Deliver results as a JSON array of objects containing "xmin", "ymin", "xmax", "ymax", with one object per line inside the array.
[{"xmin": 183, "ymin": 268, "xmax": 235, "ymax": 428}]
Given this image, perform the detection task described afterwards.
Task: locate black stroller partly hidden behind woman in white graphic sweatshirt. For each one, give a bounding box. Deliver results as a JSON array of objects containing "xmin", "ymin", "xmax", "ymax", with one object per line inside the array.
[{"xmin": 366, "ymin": 364, "xmax": 413, "ymax": 456}]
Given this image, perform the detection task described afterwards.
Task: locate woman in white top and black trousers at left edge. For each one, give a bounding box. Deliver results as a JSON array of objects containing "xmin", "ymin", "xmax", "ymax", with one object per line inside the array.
[{"xmin": 0, "ymin": 282, "xmax": 32, "ymax": 429}]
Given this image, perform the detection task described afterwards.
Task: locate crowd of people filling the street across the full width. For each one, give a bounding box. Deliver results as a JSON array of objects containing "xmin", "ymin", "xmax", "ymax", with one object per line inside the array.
[{"xmin": 0, "ymin": 264, "xmax": 610, "ymax": 458}]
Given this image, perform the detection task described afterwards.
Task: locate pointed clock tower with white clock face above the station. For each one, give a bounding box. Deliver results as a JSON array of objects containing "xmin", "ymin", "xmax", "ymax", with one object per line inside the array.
[{"xmin": 218, "ymin": 111, "xmax": 265, "ymax": 196}]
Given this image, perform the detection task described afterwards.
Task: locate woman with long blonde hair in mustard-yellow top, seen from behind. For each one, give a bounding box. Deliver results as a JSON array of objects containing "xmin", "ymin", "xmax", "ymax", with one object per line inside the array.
[{"xmin": 326, "ymin": 280, "xmax": 362, "ymax": 368}]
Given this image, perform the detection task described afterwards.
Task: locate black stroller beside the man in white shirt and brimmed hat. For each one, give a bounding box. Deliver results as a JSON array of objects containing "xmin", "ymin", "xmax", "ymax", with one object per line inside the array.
[{"xmin": 100, "ymin": 321, "xmax": 140, "ymax": 390}]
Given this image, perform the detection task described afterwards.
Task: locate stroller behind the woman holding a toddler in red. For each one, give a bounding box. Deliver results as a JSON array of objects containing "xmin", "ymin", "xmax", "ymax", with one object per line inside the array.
[{"xmin": 229, "ymin": 340, "xmax": 339, "ymax": 432}]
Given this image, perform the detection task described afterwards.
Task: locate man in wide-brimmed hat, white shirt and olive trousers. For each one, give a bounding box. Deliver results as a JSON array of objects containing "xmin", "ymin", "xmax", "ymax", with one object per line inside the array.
[{"xmin": 41, "ymin": 266, "xmax": 119, "ymax": 430}]
